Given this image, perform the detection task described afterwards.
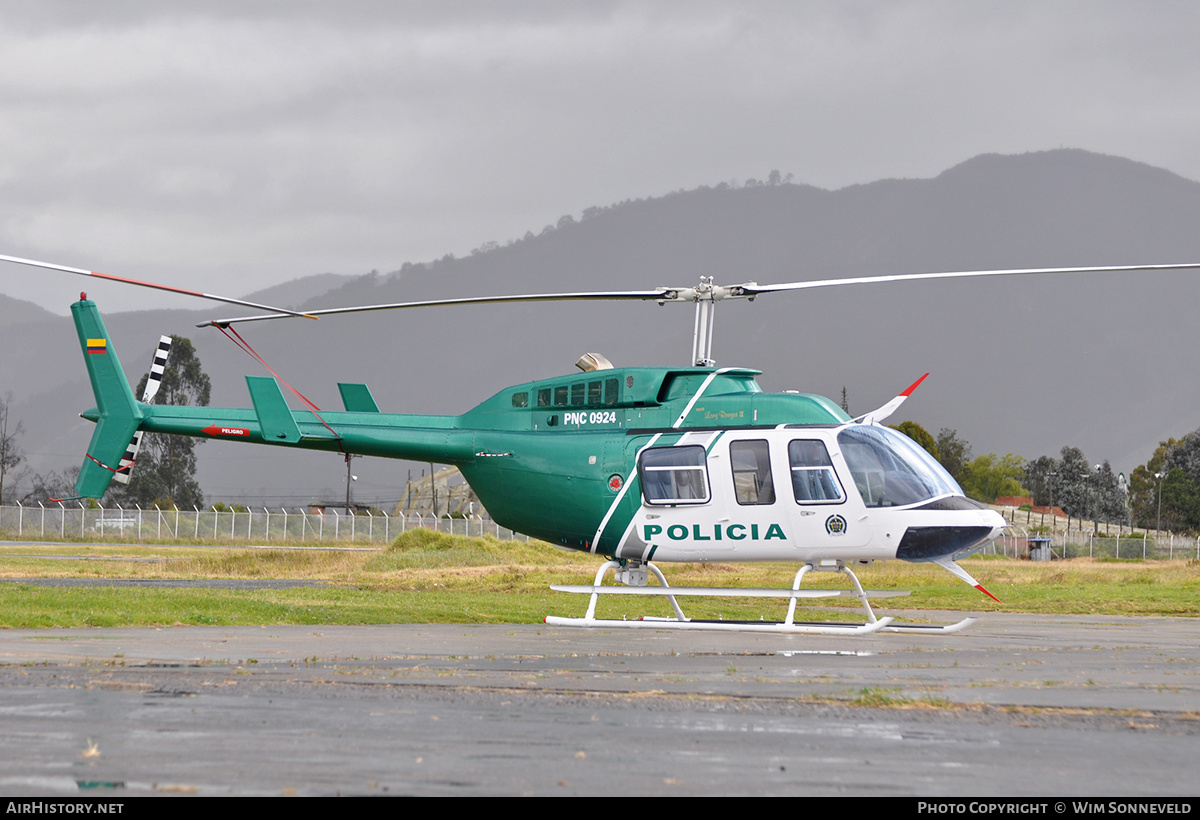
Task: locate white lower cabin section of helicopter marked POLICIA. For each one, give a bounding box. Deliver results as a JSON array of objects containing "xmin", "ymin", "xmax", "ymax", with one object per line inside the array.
[{"xmin": 618, "ymin": 424, "xmax": 1004, "ymax": 562}]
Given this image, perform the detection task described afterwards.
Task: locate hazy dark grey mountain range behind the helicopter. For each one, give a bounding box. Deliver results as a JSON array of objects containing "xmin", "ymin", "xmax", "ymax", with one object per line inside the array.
[{"xmin": 0, "ymin": 150, "xmax": 1200, "ymax": 505}]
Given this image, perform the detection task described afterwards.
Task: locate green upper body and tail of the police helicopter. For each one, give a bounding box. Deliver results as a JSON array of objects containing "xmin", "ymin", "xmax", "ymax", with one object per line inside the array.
[{"xmin": 73, "ymin": 291, "xmax": 847, "ymax": 552}]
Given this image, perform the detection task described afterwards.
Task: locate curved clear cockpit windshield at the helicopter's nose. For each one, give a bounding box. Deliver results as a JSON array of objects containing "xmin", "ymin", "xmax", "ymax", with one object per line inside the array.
[{"xmin": 838, "ymin": 425, "xmax": 964, "ymax": 507}]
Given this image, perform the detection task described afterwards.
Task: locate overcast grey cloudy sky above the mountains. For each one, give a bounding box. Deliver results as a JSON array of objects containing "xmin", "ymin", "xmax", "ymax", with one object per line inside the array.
[{"xmin": 0, "ymin": 0, "xmax": 1200, "ymax": 313}]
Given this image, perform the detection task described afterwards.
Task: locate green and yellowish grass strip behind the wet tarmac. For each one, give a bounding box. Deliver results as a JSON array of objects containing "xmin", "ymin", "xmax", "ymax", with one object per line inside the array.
[{"xmin": 0, "ymin": 529, "xmax": 1200, "ymax": 627}]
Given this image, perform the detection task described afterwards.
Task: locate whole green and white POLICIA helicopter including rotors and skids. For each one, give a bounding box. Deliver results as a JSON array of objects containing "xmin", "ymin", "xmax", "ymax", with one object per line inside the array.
[{"xmin": 0, "ymin": 256, "xmax": 1200, "ymax": 634}]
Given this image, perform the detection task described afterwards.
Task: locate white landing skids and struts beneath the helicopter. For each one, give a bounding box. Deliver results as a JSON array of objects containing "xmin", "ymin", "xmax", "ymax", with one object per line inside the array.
[{"xmin": 545, "ymin": 561, "xmax": 976, "ymax": 635}]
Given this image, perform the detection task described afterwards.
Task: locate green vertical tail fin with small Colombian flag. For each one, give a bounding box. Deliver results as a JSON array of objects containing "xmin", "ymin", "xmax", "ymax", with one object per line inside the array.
[{"xmin": 71, "ymin": 298, "xmax": 142, "ymax": 498}]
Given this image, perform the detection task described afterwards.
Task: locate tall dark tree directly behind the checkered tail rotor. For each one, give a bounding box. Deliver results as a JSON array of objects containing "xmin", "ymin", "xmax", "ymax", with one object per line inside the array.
[{"xmin": 116, "ymin": 336, "xmax": 212, "ymax": 507}]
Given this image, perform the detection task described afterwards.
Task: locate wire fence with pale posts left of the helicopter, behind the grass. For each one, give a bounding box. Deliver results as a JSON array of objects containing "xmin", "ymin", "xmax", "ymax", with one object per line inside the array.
[{"xmin": 0, "ymin": 504, "xmax": 527, "ymax": 545}]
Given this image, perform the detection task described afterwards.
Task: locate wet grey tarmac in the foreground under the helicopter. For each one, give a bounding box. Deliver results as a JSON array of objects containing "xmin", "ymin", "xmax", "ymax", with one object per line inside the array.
[{"xmin": 0, "ymin": 612, "xmax": 1200, "ymax": 800}]
